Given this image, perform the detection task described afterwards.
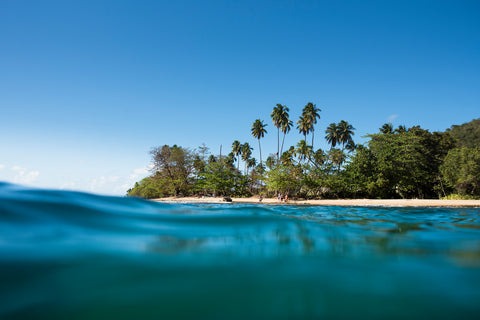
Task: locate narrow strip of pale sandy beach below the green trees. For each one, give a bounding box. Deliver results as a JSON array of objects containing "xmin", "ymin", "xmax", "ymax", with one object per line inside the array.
[{"xmin": 150, "ymin": 197, "xmax": 480, "ymax": 208}]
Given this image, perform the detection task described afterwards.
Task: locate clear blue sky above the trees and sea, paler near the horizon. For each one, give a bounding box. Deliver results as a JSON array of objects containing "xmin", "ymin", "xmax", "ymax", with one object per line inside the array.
[{"xmin": 0, "ymin": 0, "xmax": 480, "ymax": 195}]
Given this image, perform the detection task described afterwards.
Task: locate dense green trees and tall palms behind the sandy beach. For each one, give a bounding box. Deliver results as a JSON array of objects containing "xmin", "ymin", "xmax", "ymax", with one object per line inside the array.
[{"xmin": 128, "ymin": 110, "xmax": 480, "ymax": 199}]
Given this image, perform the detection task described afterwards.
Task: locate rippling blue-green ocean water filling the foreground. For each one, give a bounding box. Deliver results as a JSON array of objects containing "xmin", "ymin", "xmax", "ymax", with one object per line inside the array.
[{"xmin": 0, "ymin": 184, "xmax": 480, "ymax": 319}]
